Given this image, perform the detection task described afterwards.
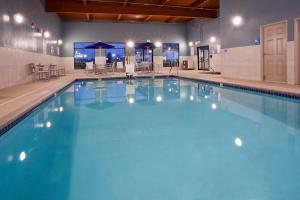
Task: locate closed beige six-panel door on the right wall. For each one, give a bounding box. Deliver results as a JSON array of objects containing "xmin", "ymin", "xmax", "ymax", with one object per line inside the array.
[{"xmin": 263, "ymin": 22, "xmax": 287, "ymax": 82}]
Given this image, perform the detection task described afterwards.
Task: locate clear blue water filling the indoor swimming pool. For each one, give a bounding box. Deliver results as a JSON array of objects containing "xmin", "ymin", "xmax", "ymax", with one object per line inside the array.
[{"xmin": 0, "ymin": 78, "xmax": 300, "ymax": 200}]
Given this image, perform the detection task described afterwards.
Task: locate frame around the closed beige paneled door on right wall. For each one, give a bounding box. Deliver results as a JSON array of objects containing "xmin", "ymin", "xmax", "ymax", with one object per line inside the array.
[{"xmin": 260, "ymin": 20, "xmax": 288, "ymax": 83}]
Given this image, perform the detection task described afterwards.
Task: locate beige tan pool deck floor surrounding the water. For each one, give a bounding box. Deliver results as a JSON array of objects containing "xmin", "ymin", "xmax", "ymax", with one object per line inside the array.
[{"xmin": 0, "ymin": 71, "xmax": 300, "ymax": 135}]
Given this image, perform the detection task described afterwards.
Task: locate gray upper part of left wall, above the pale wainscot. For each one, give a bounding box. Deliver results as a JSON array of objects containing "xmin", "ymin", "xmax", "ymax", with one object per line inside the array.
[{"xmin": 0, "ymin": 0, "xmax": 62, "ymax": 53}]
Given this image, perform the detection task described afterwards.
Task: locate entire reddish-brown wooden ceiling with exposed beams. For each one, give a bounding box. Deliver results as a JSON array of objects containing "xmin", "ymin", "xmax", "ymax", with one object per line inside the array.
[{"xmin": 45, "ymin": 0, "xmax": 220, "ymax": 23}]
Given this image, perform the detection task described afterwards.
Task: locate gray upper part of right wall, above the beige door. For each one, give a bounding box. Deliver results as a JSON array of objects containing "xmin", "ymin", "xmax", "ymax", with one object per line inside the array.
[{"xmin": 187, "ymin": 0, "xmax": 300, "ymax": 48}]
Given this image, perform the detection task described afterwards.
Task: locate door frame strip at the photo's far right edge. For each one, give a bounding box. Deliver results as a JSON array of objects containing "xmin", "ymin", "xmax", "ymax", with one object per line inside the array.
[{"xmin": 294, "ymin": 17, "xmax": 300, "ymax": 84}]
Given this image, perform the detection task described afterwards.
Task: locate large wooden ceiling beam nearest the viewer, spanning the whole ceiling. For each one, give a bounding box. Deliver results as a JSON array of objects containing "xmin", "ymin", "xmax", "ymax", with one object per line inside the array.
[{"xmin": 45, "ymin": 0, "xmax": 218, "ymax": 18}]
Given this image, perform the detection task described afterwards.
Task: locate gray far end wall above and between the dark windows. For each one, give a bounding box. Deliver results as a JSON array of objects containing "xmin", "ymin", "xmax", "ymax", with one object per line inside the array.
[{"xmin": 62, "ymin": 21, "xmax": 188, "ymax": 57}]
